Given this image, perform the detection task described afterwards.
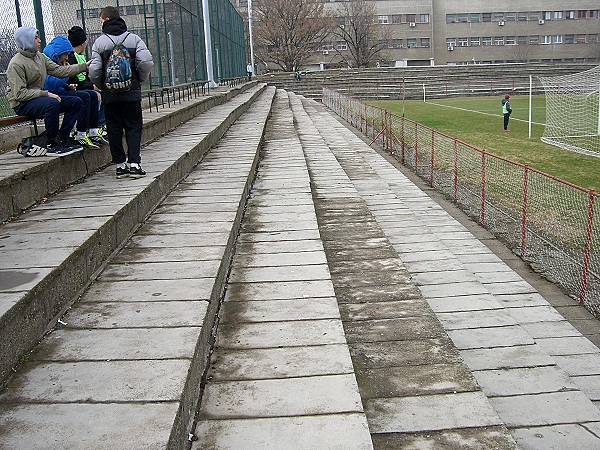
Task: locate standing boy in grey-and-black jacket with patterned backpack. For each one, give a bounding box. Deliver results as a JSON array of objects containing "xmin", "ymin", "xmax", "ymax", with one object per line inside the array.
[{"xmin": 89, "ymin": 6, "xmax": 154, "ymax": 178}]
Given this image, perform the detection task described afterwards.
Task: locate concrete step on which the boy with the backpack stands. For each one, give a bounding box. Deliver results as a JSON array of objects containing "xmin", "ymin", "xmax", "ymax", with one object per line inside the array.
[{"xmin": 0, "ymin": 81, "xmax": 265, "ymax": 385}]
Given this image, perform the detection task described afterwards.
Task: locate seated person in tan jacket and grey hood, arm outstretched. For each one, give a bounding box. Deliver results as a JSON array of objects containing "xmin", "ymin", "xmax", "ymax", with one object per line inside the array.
[{"xmin": 6, "ymin": 27, "xmax": 88, "ymax": 156}]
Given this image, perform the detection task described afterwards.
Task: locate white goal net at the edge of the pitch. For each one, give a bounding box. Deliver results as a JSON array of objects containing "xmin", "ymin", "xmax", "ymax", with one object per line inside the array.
[{"xmin": 539, "ymin": 66, "xmax": 600, "ymax": 157}]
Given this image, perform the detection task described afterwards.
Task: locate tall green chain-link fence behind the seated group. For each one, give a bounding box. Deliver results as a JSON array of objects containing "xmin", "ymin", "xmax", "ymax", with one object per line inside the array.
[{"xmin": 0, "ymin": 0, "xmax": 246, "ymax": 117}]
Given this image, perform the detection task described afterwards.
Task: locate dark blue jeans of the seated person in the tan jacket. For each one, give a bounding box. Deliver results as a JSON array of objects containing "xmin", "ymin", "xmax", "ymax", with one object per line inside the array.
[{"xmin": 14, "ymin": 96, "xmax": 81, "ymax": 140}]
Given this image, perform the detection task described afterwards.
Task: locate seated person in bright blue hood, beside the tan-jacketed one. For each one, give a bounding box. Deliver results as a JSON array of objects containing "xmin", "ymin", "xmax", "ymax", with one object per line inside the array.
[{"xmin": 44, "ymin": 35, "xmax": 108, "ymax": 148}]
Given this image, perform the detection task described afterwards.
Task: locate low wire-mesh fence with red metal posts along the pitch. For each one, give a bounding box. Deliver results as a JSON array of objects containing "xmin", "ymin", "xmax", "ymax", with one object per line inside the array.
[{"xmin": 323, "ymin": 89, "xmax": 600, "ymax": 317}]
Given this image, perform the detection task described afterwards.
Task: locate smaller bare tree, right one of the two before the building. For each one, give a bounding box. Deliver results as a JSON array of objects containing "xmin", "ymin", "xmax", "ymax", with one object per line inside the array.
[{"xmin": 332, "ymin": 0, "xmax": 387, "ymax": 67}]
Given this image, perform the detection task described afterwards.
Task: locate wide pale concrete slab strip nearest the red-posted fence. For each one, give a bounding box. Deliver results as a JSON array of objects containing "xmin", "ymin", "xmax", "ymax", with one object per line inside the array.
[{"xmin": 304, "ymin": 93, "xmax": 600, "ymax": 448}]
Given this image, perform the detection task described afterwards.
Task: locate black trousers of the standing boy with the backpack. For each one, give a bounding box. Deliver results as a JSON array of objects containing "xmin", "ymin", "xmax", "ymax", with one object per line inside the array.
[{"xmin": 104, "ymin": 102, "xmax": 143, "ymax": 164}]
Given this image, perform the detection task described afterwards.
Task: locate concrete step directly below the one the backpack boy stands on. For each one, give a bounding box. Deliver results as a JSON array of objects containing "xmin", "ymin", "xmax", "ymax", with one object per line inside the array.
[{"xmin": 0, "ymin": 88, "xmax": 275, "ymax": 449}]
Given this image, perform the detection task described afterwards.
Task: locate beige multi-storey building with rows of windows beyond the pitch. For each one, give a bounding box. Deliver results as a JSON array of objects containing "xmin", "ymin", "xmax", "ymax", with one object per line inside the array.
[{"xmin": 232, "ymin": 0, "xmax": 600, "ymax": 68}]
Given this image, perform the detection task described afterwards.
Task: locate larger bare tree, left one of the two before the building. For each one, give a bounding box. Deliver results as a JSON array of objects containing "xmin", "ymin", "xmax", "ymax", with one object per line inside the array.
[{"xmin": 254, "ymin": 0, "xmax": 333, "ymax": 72}]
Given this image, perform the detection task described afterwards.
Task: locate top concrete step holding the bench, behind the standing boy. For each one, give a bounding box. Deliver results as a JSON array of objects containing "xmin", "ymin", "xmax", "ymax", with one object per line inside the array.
[{"xmin": 0, "ymin": 83, "xmax": 255, "ymax": 223}]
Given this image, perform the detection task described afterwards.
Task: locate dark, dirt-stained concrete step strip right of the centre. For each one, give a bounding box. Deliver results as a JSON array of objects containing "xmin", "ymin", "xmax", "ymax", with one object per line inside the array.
[{"xmin": 291, "ymin": 91, "xmax": 517, "ymax": 449}]
